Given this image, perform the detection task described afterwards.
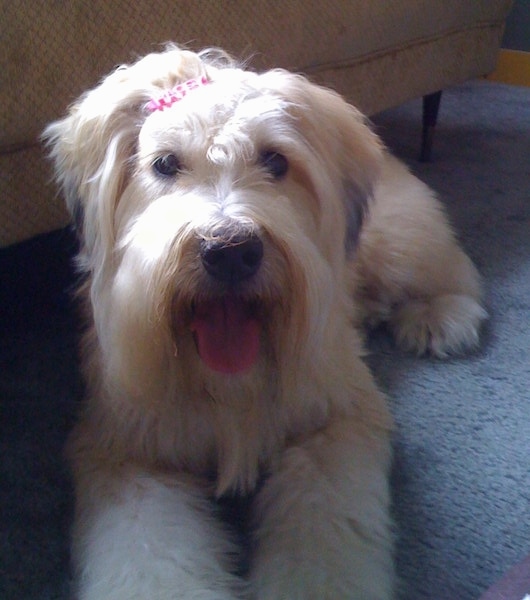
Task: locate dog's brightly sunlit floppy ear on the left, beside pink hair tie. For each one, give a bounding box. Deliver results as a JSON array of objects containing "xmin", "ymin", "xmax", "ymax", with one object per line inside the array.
[{"xmin": 43, "ymin": 48, "xmax": 210, "ymax": 268}]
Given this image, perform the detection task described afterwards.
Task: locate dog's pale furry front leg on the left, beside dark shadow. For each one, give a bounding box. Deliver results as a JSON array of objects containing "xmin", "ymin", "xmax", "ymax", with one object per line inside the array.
[{"xmin": 74, "ymin": 466, "xmax": 241, "ymax": 600}]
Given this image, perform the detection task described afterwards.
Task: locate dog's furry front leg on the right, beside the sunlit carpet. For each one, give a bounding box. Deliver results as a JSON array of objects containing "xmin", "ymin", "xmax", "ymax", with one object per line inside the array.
[{"xmin": 251, "ymin": 420, "xmax": 394, "ymax": 600}]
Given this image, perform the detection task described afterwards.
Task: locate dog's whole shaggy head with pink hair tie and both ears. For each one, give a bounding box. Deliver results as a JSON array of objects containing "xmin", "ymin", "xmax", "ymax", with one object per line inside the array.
[{"xmin": 46, "ymin": 49, "xmax": 382, "ymax": 404}]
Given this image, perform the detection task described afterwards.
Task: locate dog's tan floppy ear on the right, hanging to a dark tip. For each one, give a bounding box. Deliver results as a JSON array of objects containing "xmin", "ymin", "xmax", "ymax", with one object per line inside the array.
[{"xmin": 258, "ymin": 70, "xmax": 385, "ymax": 252}]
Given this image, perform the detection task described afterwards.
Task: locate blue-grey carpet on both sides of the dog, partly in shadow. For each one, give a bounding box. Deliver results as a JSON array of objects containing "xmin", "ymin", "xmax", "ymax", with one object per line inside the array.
[{"xmin": 0, "ymin": 82, "xmax": 530, "ymax": 600}]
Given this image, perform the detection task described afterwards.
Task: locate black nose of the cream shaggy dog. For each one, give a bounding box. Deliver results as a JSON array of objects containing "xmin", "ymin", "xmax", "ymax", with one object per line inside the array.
[{"xmin": 200, "ymin": 235, "xmax": 263, "ymax": 284}]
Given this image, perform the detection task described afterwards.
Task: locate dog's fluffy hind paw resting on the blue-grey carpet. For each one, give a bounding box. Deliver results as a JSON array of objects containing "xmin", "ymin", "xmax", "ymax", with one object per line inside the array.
[{"xmin": 390, "ymin": 294, "xmax": 487, "ymax": 358}]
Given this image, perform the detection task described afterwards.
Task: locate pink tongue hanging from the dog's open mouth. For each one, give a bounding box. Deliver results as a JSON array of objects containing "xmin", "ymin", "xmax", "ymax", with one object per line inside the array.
[{"xmin": 191, "ymin": 297, "xmax": 261, "ymax": 374}]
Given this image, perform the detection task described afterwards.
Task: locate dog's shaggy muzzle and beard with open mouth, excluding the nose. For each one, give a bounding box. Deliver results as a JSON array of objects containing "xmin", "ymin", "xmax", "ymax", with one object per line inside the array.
[{"xmin": 95, "ymin": 171, "xmax": 334, "ymax": 414}]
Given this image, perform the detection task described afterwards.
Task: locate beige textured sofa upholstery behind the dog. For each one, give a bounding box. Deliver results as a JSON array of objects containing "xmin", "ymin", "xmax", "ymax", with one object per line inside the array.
[{"xmin": 0, "ymin": 0, "xmax": 511, "ymax": 245}]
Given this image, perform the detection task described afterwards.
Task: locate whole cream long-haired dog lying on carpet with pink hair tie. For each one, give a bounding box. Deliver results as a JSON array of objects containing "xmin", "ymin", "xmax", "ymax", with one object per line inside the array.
[{"xmin": 44, "ymin": 46, "xmax": 486, "ymax": 600}]
